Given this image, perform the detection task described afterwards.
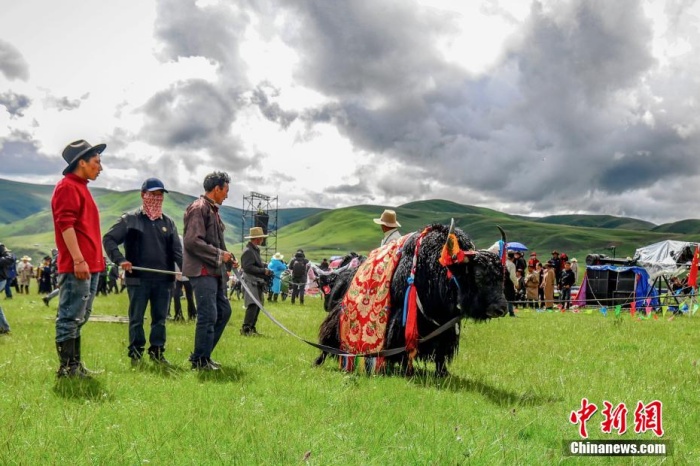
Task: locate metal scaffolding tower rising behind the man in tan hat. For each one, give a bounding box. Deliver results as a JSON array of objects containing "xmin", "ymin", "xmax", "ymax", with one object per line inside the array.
[{"xmin": 241, "ymin": 191, "xmax": 278, "ymax": 263}]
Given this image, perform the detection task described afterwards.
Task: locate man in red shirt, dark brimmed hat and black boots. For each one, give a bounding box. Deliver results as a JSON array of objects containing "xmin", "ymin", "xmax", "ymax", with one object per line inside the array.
[{"xmin": 51, "ymin": 139, "xmax": 106, "ymax": 377}]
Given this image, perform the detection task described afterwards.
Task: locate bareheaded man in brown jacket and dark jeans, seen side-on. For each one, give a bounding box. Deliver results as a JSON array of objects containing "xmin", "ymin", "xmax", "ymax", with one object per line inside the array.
[{"xmin": 182, "ymin": 172, "xmax": 238, "ymax": 371}]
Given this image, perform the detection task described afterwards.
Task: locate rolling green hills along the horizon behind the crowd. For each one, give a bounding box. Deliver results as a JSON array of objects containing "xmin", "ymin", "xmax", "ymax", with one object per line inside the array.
[{"xmin": 0, "ymin": 179, "xmax": 700, "ymax": 262}]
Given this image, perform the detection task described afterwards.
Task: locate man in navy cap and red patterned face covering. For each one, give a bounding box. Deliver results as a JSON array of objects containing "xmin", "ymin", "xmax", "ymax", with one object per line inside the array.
[{"xmin": 102, "ymin": 178, "xmax": 182, "ymax": 366}]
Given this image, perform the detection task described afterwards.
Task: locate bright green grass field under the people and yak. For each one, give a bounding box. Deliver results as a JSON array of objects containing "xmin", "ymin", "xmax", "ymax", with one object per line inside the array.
[{"xmin": 0, "ymin": 294, "xmax": 700, "ymax": 465}]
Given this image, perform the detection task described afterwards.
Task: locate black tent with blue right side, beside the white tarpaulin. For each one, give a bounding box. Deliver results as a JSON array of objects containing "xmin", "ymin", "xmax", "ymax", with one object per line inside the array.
[{"xmin": 572, "ymin": 265, "xmax": 660, "ymax": 309}]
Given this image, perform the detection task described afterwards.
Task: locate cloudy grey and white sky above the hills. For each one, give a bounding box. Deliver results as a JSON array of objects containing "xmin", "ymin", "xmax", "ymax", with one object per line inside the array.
[{"xmin": 0, "ymin": 0, "xmax": 700, "ymax": 223}]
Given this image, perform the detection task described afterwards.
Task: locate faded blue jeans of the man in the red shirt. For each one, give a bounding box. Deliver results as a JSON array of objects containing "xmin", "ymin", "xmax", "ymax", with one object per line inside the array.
[{"xmin": 56, "ymin": 273, "xmax": 100, "ymax": 343}]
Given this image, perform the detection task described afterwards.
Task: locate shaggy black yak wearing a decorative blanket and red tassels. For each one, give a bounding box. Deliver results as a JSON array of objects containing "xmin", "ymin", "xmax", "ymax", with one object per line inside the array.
[{"xmin": 315, "ymin": 224, "xmax": 507, "ymax": 377}]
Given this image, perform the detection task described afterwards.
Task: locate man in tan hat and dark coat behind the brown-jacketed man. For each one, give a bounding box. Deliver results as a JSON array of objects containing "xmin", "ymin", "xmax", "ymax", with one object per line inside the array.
[{"xmin": 241, "ymin": 227, "xmax": 273, "ymax": 336}]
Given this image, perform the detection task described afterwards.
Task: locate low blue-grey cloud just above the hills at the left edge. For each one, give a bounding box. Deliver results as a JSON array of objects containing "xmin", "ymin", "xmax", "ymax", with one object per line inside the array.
[{"xmin": 0, "ymin": 132, "xmax": 65, "ymax": 177}]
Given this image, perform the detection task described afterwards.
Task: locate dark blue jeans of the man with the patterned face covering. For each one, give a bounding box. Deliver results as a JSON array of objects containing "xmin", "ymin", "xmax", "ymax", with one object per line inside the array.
[{"xmin": 126, "ymin": 280, "xmax": 173, "ymax": 359}]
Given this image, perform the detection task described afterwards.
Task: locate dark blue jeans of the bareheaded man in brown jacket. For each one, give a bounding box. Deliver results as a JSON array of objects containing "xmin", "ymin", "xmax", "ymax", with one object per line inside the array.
[{"xmin": 189, "ymin": 276, "xmax": 231, "ymax": 362}]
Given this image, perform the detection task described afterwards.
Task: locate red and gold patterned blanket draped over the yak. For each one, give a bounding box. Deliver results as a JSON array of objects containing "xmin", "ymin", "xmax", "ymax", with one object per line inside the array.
[{"xmin": 340, "ymin": 235, "xmax": 411, "ymax": 362}]
